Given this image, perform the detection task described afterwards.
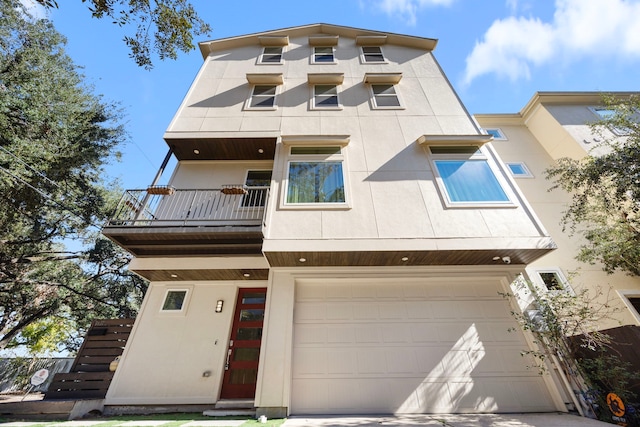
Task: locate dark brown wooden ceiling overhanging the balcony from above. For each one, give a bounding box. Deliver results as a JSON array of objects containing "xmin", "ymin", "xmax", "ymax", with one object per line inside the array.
[{"xmin": 165, "ymin": 137, "xmax": 276, "ymax": 160}]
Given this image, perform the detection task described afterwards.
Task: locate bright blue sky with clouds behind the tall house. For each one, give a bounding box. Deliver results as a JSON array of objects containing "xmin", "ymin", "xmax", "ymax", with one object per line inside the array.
[{"xmin": 23, "ymin": 0, "xmax": 640, "ymax": 188}]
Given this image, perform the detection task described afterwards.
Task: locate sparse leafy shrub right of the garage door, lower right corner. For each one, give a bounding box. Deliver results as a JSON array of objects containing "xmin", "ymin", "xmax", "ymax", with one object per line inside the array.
[{"xmin": 503, "ymin": 278, "xmax": 640, "ymax": 420}]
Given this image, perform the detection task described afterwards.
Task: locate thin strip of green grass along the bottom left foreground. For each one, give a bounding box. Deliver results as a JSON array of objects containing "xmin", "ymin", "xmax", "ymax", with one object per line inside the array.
[{"xmin": 0, "ymin": 413, "xmax": 285, "ymax": 427}]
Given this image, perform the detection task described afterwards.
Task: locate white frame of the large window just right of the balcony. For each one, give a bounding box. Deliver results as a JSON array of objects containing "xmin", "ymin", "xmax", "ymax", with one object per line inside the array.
[{"xmin": 280, "ymin": 144, "xmax": 350, "ymax": 209}]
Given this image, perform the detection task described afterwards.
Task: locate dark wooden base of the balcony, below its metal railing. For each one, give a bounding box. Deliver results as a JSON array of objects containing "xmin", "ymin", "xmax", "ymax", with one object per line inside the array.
[{"xmin": 102, "ymin": 226, "xmax": 263, "ymax": 257}]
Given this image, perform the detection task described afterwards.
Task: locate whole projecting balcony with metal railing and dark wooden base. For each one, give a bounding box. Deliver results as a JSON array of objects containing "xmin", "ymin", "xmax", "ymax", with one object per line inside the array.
[{"xmin": 102, "ymin": 185, "xmax": 269, "ymax": 256}]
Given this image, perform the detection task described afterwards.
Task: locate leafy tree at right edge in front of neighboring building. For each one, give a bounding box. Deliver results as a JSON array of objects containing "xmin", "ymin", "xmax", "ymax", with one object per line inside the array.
[{"xmin": 547, "ymin": 96, "xmax": 640, "ymax": 276}]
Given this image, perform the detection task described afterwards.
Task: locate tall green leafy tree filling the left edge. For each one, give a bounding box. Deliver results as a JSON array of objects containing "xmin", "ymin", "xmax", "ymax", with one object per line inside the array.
[{"xmin": 0, "ymin": 0, "xmax": 146, "ymax": 349}]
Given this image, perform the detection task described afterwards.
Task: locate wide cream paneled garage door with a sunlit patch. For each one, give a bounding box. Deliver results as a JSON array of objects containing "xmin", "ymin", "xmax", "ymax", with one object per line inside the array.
[{"xmin": 291, "ymin": 278, "xmax": 556, "ymax": 414}]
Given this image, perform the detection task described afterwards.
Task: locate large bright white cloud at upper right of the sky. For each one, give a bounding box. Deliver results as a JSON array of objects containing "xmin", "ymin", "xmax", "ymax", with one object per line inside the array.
[{"xmin": 463, "ymin": 0, "xmax": 640, "ymax": 85}]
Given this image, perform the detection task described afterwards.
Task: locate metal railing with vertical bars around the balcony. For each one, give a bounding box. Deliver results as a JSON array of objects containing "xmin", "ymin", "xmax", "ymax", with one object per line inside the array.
[{"xmin": 106, "ymin": 185, "xmax": 269, "ymax": 227}]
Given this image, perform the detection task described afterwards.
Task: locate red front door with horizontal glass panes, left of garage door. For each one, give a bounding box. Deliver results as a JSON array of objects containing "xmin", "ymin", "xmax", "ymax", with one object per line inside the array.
[{"xmin": 220, "ymin": 288, "xmax": 267, "ymax": 399}]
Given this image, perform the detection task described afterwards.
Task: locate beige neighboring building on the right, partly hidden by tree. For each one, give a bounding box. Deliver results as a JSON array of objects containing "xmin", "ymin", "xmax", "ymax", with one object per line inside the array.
[{"xmin": 475, "ymin": 92, "xmax": 640, "ymax": 332}]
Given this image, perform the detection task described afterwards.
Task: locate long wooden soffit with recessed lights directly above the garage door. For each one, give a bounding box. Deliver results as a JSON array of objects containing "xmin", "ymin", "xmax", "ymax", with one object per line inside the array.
[{"xmin": 264, "ymin": 248, "xmax": 553, "ymax": 267}]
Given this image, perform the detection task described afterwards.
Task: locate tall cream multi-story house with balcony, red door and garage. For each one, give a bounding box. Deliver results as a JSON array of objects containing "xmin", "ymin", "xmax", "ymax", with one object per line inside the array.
[{"xmin": 103, "ymin": 24, "xmax": 569, "ymax": 417}]
